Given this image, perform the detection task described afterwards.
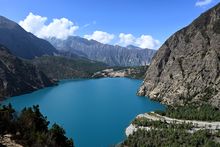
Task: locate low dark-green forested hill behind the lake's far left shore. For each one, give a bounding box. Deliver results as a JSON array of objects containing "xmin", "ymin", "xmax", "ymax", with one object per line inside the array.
[{"xmin": 30, "ymin": 56, "xmax": 107, "ymax": 80}]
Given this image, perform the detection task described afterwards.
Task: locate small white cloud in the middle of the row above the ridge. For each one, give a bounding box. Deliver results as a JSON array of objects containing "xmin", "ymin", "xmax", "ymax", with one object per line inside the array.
[{"xmin": 84, "ymin": 31, "xmax": 115, "ymax": 44}]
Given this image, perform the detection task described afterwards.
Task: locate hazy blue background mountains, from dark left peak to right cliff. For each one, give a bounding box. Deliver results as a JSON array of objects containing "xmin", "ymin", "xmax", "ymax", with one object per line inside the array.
[{"xmin": 0, "ymin": 16, "xmax": 156, "ymax": 66}]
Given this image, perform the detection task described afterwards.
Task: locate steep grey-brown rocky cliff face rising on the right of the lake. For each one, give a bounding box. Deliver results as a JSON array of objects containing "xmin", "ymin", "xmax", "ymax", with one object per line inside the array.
[{"xmin": 138, "ymin": 4, "xmax": 220, "ymax": 106}]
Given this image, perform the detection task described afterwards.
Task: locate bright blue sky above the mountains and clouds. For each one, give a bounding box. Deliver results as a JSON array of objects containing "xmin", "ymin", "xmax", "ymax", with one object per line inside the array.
[{"xmin": 0, "ymin": 0, "xmax": 220, "ymax": 48}]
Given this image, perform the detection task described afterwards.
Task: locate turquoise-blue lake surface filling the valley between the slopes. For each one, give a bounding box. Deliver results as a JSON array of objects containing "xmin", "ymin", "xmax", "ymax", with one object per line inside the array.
[{"xmin": 4, "ymin": 78, "xmax": 164, "ymax": 147}]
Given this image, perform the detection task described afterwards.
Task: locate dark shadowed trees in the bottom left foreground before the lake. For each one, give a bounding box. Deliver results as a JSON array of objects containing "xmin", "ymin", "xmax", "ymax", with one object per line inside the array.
[{"xmin": 0, "ymin": 104, "xmax": 74, "ymax": 147}]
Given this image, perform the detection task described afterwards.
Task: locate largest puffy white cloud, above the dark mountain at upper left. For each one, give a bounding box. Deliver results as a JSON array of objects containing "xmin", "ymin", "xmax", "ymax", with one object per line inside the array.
[{"xmin": 19, "ymin": 13, "xmax": 79, "ymax": 39}]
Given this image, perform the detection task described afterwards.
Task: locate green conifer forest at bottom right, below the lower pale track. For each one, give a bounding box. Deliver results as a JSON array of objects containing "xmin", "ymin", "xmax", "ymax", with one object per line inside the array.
[{"xmin": 121, "ymin": 128, "xmax": 220, "ymax": 147}]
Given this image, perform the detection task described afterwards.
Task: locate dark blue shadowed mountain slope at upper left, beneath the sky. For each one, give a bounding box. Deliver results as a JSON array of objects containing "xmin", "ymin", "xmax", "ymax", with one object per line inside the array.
[{"xmin": 0, "ymin": 16, "xmax": 57, "ymax": 59}]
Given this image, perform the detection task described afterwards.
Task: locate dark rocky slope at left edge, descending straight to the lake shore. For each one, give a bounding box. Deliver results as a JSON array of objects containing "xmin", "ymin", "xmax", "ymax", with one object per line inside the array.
[{"xmin": 0, "ymin": 45, "xmax": 54, "ymax": 99}]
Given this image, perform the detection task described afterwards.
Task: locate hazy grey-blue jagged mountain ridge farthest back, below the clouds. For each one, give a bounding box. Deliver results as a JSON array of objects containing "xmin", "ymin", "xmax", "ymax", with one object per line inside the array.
[{"xmin": 48, "ymin": 36, "xmax": 156, "ymax": 66}]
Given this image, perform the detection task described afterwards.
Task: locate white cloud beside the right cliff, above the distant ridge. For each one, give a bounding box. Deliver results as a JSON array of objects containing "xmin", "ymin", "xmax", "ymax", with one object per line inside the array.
[{"xmin": 118, "ymin": 33, "xmax": 160, "ymax": 49}]
